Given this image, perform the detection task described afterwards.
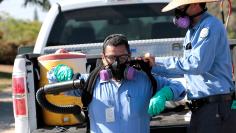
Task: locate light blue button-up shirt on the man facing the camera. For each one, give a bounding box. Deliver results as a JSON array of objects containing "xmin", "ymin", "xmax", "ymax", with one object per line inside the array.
[{"xmin": 67, "ymin": 71, "xmax": 185, "ymax": 133}]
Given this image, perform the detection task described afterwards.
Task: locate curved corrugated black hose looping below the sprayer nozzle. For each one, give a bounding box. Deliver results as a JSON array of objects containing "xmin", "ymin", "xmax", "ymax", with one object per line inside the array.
[{"xmin": 36, "ymin": 87, "xmax": 85, "ymax": 123}]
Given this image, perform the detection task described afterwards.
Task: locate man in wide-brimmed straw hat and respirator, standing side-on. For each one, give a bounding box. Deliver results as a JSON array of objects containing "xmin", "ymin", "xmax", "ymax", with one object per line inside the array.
[{"xmin": 144, "ymin": 0, "xmax": 236, "ymax": 133}]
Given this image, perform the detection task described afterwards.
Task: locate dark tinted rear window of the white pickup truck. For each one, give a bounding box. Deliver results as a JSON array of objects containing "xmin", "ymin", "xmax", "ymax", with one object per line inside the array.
[{"xmin": 47, "ymin": 3, "xmax": 186, "ymax": 46}]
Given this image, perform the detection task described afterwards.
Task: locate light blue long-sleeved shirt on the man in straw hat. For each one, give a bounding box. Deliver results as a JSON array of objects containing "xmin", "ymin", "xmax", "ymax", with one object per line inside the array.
[{"xmin": 153, "ymin": 13, "xmax": 234, "ymax": 99}]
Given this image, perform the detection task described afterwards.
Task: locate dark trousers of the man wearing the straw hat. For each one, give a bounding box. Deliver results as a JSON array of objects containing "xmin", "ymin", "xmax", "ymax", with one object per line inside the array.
[{"xmin": 188, "ymin": 101, "xmax": 236, "ymax": 133}]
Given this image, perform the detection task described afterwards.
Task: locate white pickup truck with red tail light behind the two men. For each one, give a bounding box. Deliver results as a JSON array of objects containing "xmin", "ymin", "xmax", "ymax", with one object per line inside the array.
[{"xmin": 12, "ymin": 0, "xmax": 236, "ymax": 133}]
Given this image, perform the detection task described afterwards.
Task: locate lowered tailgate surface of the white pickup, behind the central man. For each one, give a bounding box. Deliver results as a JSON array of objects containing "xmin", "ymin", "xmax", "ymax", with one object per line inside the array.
[{"xmin": 33, "ymin": 109, "xmax": 189, "ymax": 133}]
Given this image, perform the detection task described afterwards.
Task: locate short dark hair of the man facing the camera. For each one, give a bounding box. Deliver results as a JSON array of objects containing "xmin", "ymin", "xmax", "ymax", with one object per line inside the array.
[{"xmin": 102, "ymin": 34, "xmax": 131, "ymax": 54}]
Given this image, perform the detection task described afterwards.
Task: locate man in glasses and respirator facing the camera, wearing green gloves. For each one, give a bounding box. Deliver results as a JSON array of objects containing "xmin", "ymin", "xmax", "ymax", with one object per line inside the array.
[{"xmin": 68, "ymin": 34, "xmax": 186, "ymax": 133}]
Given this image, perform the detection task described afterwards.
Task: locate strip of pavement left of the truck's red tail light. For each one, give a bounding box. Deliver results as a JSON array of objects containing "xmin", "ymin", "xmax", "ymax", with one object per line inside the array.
[{"xmin": 0, "ymin": 88, "xmax": 14, "ymax": 133}]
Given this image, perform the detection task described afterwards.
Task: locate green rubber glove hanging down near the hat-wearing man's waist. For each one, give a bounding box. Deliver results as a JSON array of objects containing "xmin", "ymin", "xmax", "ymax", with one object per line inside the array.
[{"xmin": 148, "ymin": 86, "xmax": 174, "ymax": 116}]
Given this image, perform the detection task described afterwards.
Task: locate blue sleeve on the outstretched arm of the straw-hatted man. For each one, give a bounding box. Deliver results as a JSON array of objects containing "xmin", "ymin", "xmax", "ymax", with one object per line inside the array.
[{"xmin": 152, "ymin": 24, "xmax": 220, "ymax": 77}]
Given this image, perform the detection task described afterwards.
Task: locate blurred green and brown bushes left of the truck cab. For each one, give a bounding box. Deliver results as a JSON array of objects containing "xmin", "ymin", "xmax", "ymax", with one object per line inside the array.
[{"xmin": 0, "ymin": 15, "xmax": 41, "ymax": 64}]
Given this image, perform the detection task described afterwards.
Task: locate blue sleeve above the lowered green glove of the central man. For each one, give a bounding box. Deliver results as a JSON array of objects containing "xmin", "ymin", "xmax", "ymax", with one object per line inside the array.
[{"xmin": 155, "ymin": 76, "xmax": 186, "ymax": 101}]
